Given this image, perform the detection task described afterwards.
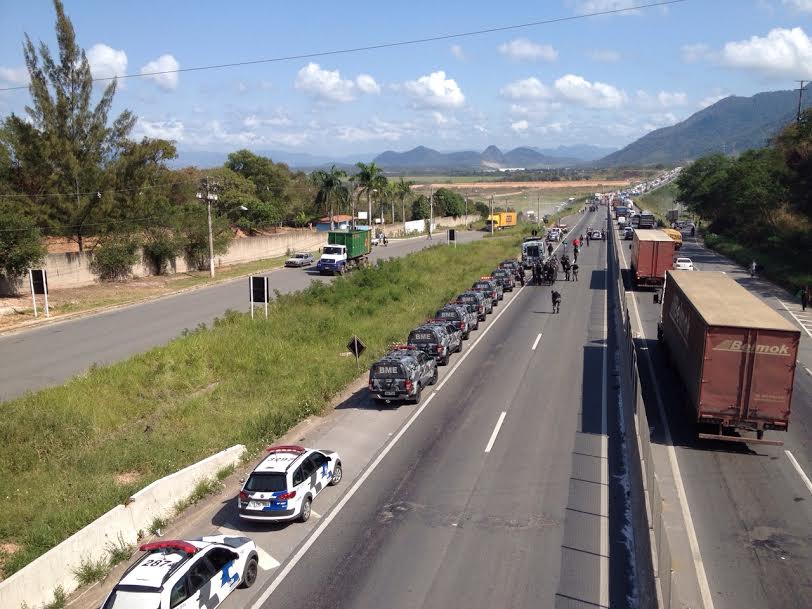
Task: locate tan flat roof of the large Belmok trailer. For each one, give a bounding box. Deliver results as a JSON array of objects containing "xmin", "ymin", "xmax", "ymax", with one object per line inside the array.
[{"xmin": 665, "ymin": 271, "xmax": 800, "ymax": 334}]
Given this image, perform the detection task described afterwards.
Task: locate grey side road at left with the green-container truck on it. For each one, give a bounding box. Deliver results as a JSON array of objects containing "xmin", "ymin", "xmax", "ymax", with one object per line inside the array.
[{"xmin": 0, "ymin": 232, "xmax": 484, "ymax": 401}]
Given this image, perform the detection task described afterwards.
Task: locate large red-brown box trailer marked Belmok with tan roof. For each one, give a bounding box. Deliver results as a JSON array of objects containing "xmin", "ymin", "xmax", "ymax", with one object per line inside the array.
[{"xmin": 657, "ymin": 271, "xmax": 801, "ymax": 445}]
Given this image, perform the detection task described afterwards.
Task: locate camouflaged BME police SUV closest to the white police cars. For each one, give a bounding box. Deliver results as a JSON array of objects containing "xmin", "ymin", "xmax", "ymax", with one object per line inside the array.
[{"xmin": 369, "ymin": 346, "xmax": 437, "ymax": 404}]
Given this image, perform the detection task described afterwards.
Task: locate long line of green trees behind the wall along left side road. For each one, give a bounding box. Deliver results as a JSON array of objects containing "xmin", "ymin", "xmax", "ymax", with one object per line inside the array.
[{"xmin": 0, "ymin": 0, "xmax": 484, "ymax": 280}]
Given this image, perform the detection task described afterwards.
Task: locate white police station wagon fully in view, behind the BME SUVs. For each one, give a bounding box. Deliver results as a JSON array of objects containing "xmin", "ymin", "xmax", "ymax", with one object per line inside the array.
[{"xmin": 237, "ymin": 445, "xmax": 343, "ymax": 522}]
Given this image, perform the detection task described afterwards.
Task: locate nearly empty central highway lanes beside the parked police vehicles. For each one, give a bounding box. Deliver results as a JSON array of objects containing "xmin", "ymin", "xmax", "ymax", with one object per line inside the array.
[{"xmin": 77, "ymin": 207, "xmax": 634, "ymax": 609}]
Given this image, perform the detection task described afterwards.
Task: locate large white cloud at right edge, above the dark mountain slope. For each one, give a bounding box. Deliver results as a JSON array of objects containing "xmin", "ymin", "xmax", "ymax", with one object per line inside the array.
[{"xmin": 721, "ymin": 27, "xmax": 812, "ymax": 79}]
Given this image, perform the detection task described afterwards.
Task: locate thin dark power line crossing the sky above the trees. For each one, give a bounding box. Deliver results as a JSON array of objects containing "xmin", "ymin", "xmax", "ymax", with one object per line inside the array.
[{"xmin": 0, "ymin": 0, "xmax": 688, "ymax": 91}]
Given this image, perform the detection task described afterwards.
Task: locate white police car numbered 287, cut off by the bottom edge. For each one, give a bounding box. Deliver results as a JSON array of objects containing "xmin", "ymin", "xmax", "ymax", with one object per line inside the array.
[{"xmin": 101, "ymin": 535, "xmax": 258, "ymax": 609}]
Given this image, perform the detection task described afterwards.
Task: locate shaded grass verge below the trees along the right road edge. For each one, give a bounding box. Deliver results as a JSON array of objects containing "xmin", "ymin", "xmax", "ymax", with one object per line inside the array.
[{"xmin": 703, "ymin": 233, "xmax": 812, "ymax": 295}]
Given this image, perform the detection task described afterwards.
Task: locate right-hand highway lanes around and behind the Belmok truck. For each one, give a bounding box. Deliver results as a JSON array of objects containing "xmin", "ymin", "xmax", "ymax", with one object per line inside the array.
[{"xmin": 621, "ymin": 224, "xmax": 812, "ymax": 609}]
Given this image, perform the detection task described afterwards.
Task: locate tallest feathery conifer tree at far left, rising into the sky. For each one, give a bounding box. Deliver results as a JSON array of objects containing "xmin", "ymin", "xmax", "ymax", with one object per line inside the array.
[{"xmin": 0, "ymin": 0, "xmax": 174, "ymax": 251}]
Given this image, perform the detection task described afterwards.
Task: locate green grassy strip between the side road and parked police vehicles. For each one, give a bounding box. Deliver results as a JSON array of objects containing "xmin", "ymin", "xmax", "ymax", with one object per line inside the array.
[{"xmin": 0, "ymin": 235, "xmax": 520, "ymax": 575}]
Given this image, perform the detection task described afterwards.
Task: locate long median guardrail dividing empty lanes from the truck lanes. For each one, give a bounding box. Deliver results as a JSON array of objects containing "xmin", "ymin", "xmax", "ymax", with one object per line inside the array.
[{"xmin": 607, "ymin": 207, "xmax": 676, "ymax": 609}]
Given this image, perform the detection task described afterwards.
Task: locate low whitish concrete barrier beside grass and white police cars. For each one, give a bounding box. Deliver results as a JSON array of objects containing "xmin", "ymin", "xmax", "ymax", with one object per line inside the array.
[{"xmin": 0, "ymin": 444, "xmax": 245, "ymax": 609}]
